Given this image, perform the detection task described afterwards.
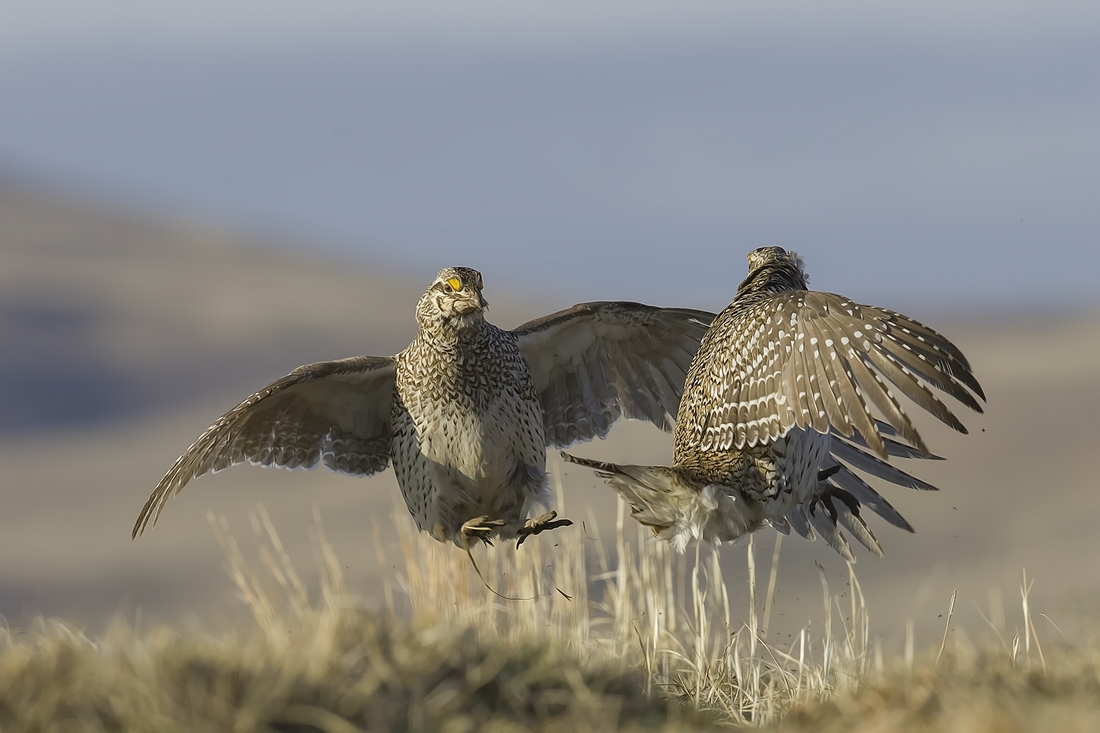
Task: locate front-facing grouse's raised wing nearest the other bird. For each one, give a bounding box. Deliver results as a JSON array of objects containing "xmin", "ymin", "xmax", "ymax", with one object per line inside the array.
[{"xmin": 513, "ymin": 303, "xmax": 714, "ymax": 448}]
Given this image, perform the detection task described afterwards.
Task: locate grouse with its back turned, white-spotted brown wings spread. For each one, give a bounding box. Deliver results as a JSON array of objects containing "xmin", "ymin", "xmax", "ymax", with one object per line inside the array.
[{"xmin": 565, "ymin": 247, "xmax": 985, "ymax": 559}]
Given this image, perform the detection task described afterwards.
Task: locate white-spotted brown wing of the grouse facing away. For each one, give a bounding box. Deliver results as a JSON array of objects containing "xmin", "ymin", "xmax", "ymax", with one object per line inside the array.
[{"xmin": 688, "ymin": 291, "xmax": 986, "ymax": 458}]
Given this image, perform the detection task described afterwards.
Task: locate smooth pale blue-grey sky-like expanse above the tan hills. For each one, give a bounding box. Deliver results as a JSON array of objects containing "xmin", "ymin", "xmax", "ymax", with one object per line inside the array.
[{"xmin": 0, "ymin": 0, "xmax": 1100, "ymax": 315}]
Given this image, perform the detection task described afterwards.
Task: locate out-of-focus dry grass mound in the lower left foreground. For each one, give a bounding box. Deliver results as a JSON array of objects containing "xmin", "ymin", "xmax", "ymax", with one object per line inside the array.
[{"xmin": 0, "ymin": 501, "xmax": 708, "ymax": 733}]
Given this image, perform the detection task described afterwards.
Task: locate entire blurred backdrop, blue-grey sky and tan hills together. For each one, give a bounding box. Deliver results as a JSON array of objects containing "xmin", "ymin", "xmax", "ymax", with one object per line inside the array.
[{"xmin": 0, "ymin": 0, "xmax": 1100, "ymax": 638}]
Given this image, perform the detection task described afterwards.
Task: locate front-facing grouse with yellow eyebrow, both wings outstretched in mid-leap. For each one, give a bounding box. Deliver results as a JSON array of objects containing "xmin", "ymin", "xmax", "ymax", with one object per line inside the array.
[{"xmin": 133, "ymin": 267, "xmax": 714, "ymax": 545}]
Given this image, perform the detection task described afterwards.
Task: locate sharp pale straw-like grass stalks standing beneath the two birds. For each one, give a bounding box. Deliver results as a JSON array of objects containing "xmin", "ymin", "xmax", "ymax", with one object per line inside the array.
[{"xmin": 380, "ymin": 468, "xmax": 882, "ymax": 723}]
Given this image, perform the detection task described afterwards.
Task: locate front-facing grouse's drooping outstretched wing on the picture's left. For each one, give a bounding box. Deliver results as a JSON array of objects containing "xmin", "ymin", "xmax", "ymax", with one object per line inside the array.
[{"xmin": 132, "ymin": 357, "xmax": 395, "ymax": 537}]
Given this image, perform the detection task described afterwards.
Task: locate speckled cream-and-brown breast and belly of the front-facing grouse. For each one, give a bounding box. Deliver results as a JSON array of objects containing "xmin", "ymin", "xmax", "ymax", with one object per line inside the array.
[{"xmin": 393, "ymin": 325, "xmax": 546, "ymax": 533}]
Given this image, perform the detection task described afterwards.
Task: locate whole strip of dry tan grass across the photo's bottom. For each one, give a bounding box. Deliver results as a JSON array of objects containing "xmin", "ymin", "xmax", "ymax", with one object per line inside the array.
[{"xmin": 0, "ymin": 477, "xmax": 1100, "ymax": 733}]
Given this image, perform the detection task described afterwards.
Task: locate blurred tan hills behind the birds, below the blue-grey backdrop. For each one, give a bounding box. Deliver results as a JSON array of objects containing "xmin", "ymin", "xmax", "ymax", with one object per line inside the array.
[{"xmin": 0, "ymin": 187, "xmax": 1100, "ymax": 641}]
